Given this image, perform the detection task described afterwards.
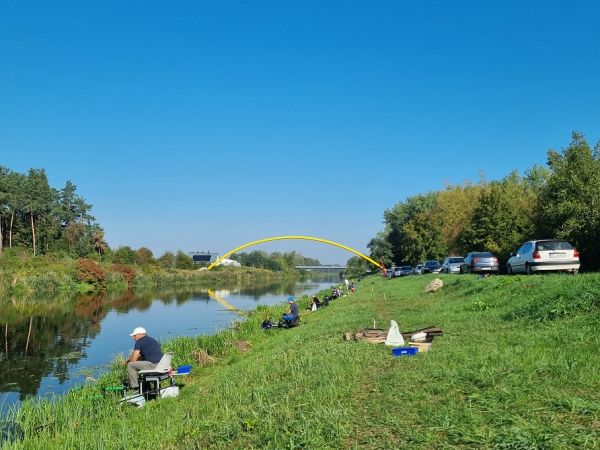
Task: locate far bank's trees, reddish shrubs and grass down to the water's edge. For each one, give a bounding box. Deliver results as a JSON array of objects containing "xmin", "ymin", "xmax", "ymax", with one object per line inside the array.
[{"xmin": 0, "ymin": 166, "xmax": 319, "ymax": 298}]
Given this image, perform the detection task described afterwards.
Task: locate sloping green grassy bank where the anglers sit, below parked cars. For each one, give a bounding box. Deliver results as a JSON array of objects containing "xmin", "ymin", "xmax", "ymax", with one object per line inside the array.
[{"xmin": 8, "ymin": 274, "xmax": 600, "ymax": 449}]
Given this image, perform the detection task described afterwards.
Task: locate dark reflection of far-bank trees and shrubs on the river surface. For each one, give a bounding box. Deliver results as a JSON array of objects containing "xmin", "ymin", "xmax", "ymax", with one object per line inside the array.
[{"xmin": 0, "ymin": 280, "xmax": 340, "ymax": 406}]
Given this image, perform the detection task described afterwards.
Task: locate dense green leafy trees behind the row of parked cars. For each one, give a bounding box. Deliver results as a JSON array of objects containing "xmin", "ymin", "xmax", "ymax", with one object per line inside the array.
[{"xmin": 366, "ymin": 132, "xmax": 600, "ymax": 270}]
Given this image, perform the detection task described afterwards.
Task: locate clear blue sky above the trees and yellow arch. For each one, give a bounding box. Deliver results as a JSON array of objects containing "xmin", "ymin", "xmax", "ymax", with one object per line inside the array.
[{"xmin": 0, "ymin": 0, "xmax": 600, "ymax": 263}]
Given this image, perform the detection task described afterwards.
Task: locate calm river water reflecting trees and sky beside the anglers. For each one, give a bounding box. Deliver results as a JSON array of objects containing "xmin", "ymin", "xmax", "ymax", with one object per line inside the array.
[{"xmin": 0, "ymin": 274, "xmax": 339, "ymax": 411}]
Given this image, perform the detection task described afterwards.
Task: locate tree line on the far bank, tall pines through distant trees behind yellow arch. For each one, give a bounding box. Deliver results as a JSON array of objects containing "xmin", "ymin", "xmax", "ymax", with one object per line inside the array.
[{"xmin": 0, "ymin": 166, "xmax": 319, "ymax": 271}]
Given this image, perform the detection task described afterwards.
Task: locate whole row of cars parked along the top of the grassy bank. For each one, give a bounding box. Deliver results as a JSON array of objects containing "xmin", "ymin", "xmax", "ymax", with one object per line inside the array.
[{"xmin": 390, "ymin": 239, "xmax": 580, "ymax": 277}]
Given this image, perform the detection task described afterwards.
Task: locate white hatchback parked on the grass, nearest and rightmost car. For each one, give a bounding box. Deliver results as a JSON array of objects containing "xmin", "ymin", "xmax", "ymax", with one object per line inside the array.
[{"xmin": 506, "ymin": 239, "xmax": 579, "ymax": 275}]
